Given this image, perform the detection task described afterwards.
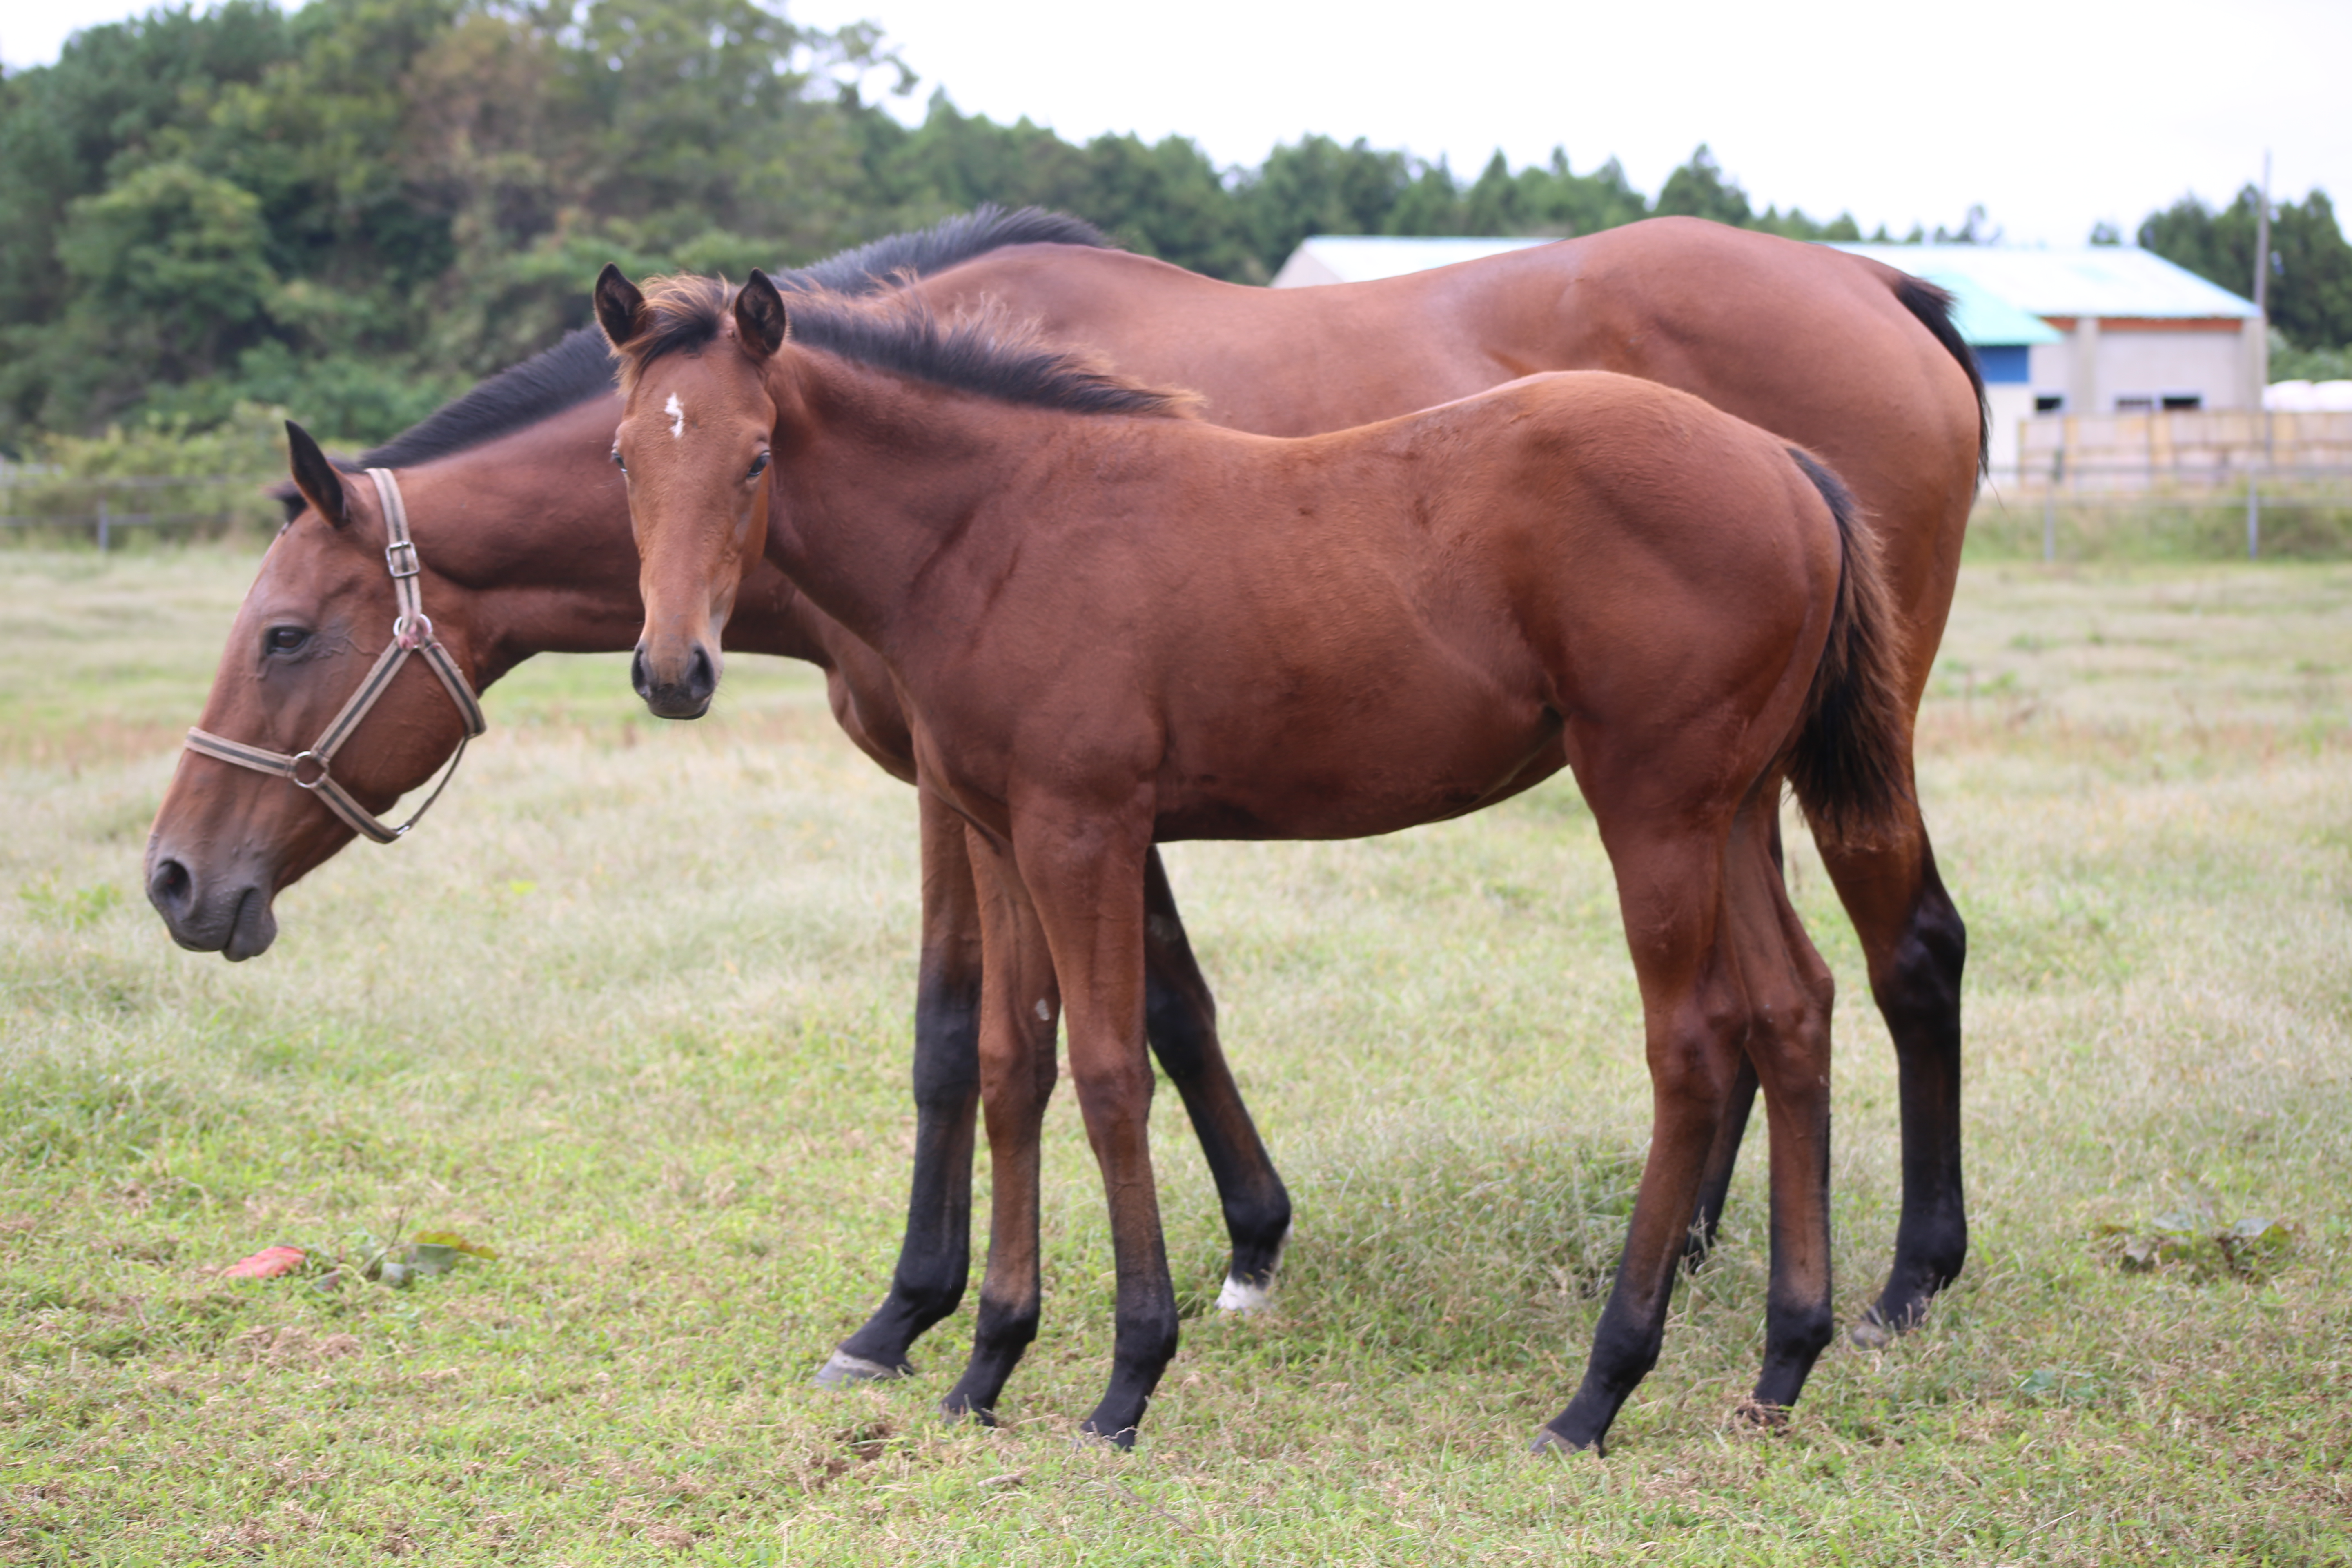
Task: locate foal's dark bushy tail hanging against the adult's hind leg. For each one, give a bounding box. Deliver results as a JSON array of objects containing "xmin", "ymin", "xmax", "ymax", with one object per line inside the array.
[{"xmin": 1788, "ymin": 447, "xmax": 1910, "ymax": 846}]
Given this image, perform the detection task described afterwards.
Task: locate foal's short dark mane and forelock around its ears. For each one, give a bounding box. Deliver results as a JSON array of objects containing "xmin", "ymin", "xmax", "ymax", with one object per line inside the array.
[{"xmin": 616, "ymin": 273, "xmax": 1195, "ymax": 414}]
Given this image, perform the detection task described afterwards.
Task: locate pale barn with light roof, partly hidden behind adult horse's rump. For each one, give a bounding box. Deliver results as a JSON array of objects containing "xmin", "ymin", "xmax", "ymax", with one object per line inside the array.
[{"xmin": 1275, "ymin": 235, "xmax": 2270, "ymax": 470}]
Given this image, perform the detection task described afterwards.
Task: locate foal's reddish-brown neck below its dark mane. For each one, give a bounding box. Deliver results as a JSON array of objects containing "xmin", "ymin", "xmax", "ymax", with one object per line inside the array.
[{"xmin": 767, "ymin": 348, "xmax": 1049, "ymax": 661}]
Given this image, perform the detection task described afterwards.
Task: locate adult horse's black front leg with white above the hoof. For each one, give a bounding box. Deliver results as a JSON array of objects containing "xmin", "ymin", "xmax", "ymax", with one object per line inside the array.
[{"xmin": 1143, "ymin": 849, "xmax": 1291, "ymax": 1312}]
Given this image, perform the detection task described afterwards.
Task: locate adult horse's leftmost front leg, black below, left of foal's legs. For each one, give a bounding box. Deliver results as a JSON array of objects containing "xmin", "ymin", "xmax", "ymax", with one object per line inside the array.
[{"xmin": 816, "ymin": 792, "xmax": 981, "ymax": 1387}]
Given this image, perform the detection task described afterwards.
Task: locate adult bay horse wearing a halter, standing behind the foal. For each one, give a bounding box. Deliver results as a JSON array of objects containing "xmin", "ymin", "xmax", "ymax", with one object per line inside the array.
[{"xmin": 148, "ymin": 212, "xmax": 1973, "ymax": 1401}]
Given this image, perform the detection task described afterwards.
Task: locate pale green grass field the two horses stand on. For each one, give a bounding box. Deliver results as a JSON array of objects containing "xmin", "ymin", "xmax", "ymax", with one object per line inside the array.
[{"xmin": 0, "ymin": 550, "xmax": 2352, "ymax": 1563}]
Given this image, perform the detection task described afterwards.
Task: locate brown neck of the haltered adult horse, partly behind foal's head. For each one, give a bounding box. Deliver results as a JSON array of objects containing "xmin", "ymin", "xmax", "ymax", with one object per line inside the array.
[{"xmin": 400, "ymin": 395, "xmax": 835, "ymax": 686}]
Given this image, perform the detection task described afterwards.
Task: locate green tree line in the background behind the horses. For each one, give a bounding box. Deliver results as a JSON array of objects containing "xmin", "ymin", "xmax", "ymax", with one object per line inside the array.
[{"xmin": 0, "ymin": 0, "xmax": 2352, "ymax": 456}]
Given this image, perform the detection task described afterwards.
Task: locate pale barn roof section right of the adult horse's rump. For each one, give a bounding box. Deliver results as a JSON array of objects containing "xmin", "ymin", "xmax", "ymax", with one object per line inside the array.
[{"xmin": 1837, "ymin": 245, "xmax": 2253, "ymax": 320}]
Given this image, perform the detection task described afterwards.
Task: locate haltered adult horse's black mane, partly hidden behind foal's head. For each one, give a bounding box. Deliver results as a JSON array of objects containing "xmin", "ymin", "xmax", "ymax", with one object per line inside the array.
[{"xmin": 343, "ymin": 205, "xmax": 1110, "ymax": 479}]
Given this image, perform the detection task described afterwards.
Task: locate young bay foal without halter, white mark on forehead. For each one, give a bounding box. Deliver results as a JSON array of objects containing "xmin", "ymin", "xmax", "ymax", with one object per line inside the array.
[{"xmin": 597, "ymin": 268, "xmax": 1905, "ymax": 1448}]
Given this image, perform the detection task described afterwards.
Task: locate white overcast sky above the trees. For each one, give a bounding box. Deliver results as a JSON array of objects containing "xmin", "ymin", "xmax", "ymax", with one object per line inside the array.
[{"xmin": 0, "ymin": 0, "xmax": 2352, "ymax": 245}]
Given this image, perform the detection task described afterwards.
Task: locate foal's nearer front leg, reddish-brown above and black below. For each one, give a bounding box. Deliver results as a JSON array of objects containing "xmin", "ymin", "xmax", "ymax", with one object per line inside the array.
[{"xmin": 1014, "ymin": 808, "xmax": 1176, "ymax": 1448}]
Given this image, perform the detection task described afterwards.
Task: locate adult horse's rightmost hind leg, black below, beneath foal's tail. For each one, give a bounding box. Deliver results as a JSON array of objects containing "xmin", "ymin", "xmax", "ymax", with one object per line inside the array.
[{"xmin": 1820, "ymin": 790, "xmax": 1969, "ymax": 1342}]
